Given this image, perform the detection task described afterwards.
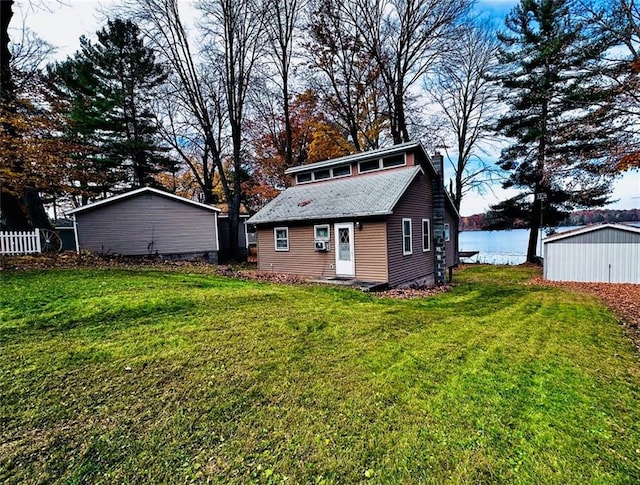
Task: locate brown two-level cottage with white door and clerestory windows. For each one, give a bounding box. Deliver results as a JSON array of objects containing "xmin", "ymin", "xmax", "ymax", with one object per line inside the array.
[{"xmin": 247, "ymin": 142, "xmax": 459, "ymax": 287}]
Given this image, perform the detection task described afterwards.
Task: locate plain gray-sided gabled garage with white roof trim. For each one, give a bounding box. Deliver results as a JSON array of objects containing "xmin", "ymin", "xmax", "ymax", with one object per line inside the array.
[{"xmin": 69, "ymin": 187, "xmax": 220, "ymax": 263}]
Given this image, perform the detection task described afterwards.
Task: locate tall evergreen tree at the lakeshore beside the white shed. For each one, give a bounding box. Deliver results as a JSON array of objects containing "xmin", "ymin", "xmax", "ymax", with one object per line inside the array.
[{"xmin": 491, "ymin": 0, "xmax": 616, "ymax": 261}]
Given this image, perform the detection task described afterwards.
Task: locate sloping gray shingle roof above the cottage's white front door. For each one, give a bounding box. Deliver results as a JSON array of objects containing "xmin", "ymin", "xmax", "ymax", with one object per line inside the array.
[{"xmin": 247, "ymin": 166, "xmax": 421, "ymax": 224}]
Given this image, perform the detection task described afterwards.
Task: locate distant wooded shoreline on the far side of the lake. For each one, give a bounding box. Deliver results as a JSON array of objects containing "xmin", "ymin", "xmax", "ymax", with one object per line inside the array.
[{"xmin": 460, "ymin": 209, "xmax": 640, "ymax": 231}]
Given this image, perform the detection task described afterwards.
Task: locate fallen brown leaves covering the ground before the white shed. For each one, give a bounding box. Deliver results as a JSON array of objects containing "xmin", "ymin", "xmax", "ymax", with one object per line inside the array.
[{"xmin": 531, "ymin": 276, "xmax": 640, "ymax": 350}]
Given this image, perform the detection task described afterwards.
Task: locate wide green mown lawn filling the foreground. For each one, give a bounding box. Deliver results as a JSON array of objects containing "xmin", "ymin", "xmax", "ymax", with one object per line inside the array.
[{"xmin": 0, "ymin": 267, "xmax": 640, "ymax": 484}]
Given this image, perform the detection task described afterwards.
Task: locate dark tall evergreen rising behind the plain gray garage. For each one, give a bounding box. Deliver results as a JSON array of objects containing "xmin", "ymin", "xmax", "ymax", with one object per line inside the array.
[{"xmin": 52, "ymin": 19, "xmax": 173, "ymax": 192}]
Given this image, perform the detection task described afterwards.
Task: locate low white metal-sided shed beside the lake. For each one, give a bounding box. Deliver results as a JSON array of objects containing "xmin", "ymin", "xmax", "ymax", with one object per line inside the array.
[{"xmin": 542, "ymin": 224, "xmax": 640, "ymax": 283}]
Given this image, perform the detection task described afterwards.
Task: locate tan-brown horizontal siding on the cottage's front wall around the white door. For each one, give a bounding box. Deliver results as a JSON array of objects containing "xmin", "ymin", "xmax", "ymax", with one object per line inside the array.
[{"xmin": 257, "ymin": 220, "xmax": 387, "ymax": 282}]
